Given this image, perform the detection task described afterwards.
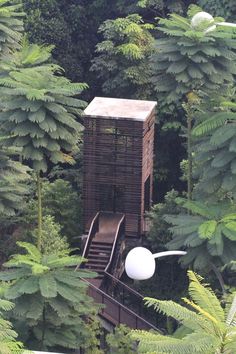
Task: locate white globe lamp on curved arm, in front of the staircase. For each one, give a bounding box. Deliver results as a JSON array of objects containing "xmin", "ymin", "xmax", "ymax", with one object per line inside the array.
[{"xmin": 125, "ymin": 247, "xmax": 187, "ymax": 280}]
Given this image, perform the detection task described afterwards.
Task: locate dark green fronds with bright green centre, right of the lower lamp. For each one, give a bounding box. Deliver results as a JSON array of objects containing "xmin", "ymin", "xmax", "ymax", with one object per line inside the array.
[{"xmin": 165, "ymin": 199, "xmax": 236, "ymax": 272}]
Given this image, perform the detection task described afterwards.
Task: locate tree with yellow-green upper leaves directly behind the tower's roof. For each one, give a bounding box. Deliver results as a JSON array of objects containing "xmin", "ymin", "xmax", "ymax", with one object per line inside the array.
[{"xmin": 91, "ymin": 14, "xmax": 153, "ymax": 98}]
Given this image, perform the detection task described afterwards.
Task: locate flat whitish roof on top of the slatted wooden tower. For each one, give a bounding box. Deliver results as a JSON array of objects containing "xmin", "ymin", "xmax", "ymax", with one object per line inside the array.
[{"xmin": 84, "ymin": 97, "xmax": 157, "ymax": 121}]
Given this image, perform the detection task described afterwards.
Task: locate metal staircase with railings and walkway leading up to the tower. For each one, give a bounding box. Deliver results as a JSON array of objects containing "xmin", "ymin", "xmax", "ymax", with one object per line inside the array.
[{"xmin": 79, "ymin": 212, "xmax": 157, "ymax": 330}]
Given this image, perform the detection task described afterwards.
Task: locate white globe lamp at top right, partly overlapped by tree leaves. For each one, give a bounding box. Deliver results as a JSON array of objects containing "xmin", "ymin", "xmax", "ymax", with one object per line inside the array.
[{"xmin": 191, "ymin": 11, "xmax": 236, "ymax": 33}]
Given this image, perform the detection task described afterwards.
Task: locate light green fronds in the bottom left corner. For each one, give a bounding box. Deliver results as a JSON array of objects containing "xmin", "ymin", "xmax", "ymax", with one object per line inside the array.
[{"xmin": 0, "ymin": 285, "xmax": 23, "ymax": 354}]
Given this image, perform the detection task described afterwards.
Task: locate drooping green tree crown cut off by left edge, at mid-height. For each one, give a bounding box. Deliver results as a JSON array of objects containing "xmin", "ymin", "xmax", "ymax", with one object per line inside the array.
[{"xmin": 0, "ymin": 147, "xmax": 30, "ymax": 217}]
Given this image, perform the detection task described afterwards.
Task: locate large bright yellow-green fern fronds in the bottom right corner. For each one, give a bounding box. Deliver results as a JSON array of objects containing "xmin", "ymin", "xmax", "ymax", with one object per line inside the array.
[{"xmin": 131, "ymin": 271, "xmax": 236, "ymax": 354}]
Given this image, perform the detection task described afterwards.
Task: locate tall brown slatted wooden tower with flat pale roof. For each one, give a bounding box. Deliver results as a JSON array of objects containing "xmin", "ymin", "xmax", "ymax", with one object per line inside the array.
[{"xmin": 83, "ymin": 97, "xmax": 156, "ymax": 237}]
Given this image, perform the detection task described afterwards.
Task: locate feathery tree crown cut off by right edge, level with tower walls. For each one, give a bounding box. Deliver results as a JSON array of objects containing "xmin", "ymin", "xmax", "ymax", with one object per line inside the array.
[{"xmin": 192, "ymin": 94, "xmax": 236, "ymax": 199}]
